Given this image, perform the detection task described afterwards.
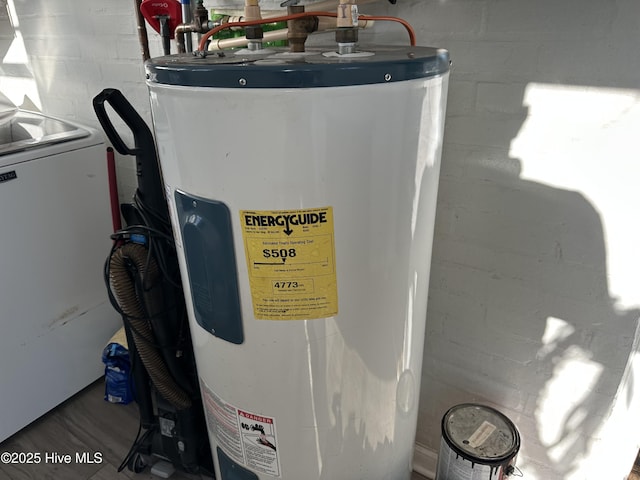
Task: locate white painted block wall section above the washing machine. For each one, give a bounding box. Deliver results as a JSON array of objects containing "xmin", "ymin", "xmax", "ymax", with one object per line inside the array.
[{"xmin": 0, "ymin": 0, "xmax": 162, "ymax": 202}]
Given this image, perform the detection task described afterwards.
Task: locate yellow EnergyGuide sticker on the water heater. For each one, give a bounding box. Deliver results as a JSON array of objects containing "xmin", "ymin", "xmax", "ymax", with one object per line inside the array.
[{"xmin": 240, "ymin": 207, "xmax": 338, "ymax": 320}]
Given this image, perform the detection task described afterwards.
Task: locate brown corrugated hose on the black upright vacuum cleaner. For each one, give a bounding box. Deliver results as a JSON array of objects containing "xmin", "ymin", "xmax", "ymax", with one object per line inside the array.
[{"xmin": 109, "ymin": 243, "xmax": 191, "ymax": 410}]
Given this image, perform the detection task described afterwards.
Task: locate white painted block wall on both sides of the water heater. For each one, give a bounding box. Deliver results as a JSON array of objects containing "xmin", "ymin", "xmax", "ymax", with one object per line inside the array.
[{"xmin": 0, "ymin": 0, "xmax": 640, "ymax": 480}]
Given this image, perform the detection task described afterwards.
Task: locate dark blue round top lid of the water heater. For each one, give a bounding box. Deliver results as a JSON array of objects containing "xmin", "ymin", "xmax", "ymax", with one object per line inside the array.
[{"xmin": 145, "ymin": 46, "xmax": 450, "ymax": 88}]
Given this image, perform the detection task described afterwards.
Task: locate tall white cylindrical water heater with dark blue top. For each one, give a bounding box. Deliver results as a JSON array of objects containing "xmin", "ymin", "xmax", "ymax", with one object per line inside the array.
[{"xmin": 146, "ymin": 47, "xmax": 449, "ymax": 480}]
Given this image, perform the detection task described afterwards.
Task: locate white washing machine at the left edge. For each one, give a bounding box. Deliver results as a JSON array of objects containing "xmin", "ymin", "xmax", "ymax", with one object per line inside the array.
[{"xmin": 0, "ymin": 110, "xmax": 120, "ymax": 441}]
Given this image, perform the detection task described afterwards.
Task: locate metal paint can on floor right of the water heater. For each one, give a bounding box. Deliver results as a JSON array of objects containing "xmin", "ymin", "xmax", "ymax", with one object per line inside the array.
[{"xmin": 436, "ymin": 403, "xmax": 520, "ymax": 480}]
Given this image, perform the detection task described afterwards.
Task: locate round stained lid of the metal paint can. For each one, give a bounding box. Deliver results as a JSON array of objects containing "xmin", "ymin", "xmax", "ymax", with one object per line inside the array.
[{"xmin": 442, "ymin": 403, "xmax": 520, "ymax": 465}]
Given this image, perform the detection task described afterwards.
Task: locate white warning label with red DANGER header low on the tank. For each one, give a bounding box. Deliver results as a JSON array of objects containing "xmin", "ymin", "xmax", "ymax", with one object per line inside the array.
[{"xmin": 200, "ymin": 380, "xmax": 281, "ymax": 477}]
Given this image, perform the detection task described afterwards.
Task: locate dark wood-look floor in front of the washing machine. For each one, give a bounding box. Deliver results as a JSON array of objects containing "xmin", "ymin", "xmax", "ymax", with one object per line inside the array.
[{"xmin": 0, "ymin": 380, "xmax": 426, "ymax": 480}]
